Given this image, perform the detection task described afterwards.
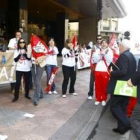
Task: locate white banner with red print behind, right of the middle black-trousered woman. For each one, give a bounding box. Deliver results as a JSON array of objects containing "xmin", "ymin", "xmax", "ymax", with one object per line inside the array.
[{"xmin": 77, "ymin": 49, "xmax": 91, "ymax": 69}]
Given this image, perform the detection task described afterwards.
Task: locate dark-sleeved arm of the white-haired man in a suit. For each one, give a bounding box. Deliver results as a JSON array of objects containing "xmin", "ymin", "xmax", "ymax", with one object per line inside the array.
[{"xmin": 111, "ymin": 55, "xmax": 129, "ymax": 78}]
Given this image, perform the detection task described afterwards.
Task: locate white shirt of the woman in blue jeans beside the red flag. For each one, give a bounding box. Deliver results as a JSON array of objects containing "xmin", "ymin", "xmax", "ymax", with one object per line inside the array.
[{"xmin": 46, "ymin": 46, "xmax": 59, "ymax": 66}]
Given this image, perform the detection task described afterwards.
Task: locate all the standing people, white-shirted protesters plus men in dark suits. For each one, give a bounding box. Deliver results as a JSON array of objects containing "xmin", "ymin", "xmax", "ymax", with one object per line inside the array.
[{"xmin": 8, "ymin": 31, "xmax": 140, "ymax": 138}]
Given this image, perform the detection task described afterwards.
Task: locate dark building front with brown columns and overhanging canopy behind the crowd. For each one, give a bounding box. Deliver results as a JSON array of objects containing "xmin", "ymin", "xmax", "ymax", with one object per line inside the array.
[{"xmin": 0, "ymin": 0, "xmax": 126, "ymax": 52}]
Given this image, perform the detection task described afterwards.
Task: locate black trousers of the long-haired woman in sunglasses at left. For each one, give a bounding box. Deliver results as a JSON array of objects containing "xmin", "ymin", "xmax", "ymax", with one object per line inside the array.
[{"xmin": 14, "ymin": 71, "xmax": 31, "ymax": 99}]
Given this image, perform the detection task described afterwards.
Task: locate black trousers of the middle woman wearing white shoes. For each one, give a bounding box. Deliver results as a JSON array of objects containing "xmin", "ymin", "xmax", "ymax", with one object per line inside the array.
[{"xmin": 62, "ymin": 65, "xmax": 76, "ymax": 95}]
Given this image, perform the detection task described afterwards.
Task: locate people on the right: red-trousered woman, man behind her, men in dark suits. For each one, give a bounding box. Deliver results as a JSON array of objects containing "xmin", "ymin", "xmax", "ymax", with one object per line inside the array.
[{"xmin": 88, "ymin": 35, "xmax": 140, "ymax": 139}]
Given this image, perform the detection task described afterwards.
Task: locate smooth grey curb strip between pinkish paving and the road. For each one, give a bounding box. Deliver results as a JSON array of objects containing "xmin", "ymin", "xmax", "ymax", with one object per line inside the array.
[{"xmin": 49, "ymin": 99, "xmax": 109, "ymax": 140}]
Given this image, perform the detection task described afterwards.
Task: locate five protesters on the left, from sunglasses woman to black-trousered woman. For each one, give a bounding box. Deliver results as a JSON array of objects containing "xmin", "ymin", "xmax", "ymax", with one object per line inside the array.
[{"xmin": 8, "ymin": 30, "xmax": 78, "ymax": 106}]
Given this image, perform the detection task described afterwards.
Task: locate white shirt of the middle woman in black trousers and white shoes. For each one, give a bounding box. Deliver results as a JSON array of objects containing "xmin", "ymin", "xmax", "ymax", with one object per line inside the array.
[{"xmin": 62, "ymin": 48, "xmax": 76, "ymax": 67}]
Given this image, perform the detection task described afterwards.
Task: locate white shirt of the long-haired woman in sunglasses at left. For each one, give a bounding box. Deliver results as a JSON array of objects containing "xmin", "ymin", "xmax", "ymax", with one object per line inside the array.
[{"xmin": 14, "ymin": 50, "xmax": 31, "ymax": 72}]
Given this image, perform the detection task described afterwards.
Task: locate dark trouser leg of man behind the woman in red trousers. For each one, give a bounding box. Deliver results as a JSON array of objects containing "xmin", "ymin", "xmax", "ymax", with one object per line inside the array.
[{"xmin": 88, "ymin": 71, "xmax": 95, "ymax": 96}]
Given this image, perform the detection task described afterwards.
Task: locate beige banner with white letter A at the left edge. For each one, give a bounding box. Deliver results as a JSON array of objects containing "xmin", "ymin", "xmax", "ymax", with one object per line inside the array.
[{"xmin": 0, "ymin": 51, "xmax": 15, "ymax": 84}]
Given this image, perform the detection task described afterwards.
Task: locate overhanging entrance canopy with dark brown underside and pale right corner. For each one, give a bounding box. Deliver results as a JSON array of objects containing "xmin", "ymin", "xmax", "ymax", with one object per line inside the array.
[{"xmin": 28, "ymin": 0, "xmax": 126, "ymax": 21}]
